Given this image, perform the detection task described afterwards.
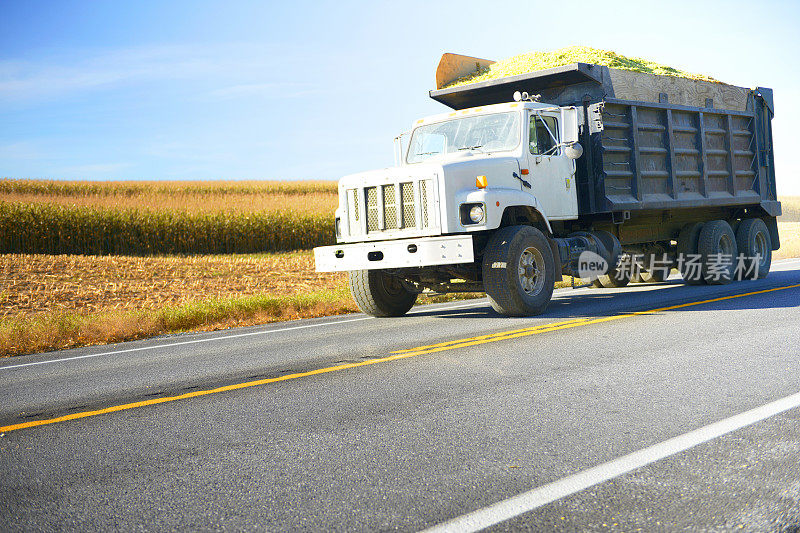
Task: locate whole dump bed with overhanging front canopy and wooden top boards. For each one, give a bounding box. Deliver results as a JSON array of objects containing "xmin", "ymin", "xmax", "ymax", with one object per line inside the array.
[{"xmin": 430, "ymin": 54, "xmax": 780, "ymax": 216}]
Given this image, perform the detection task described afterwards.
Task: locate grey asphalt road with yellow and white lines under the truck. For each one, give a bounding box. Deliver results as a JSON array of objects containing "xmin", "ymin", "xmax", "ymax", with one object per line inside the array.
[{"xmin": 0, "ymin": 260, "xmax": 800, "ymax": 532}]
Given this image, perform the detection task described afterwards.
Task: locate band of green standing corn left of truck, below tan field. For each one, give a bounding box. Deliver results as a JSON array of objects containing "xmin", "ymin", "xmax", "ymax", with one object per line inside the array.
[{"xmin": 0, "ymin": 202, "xmax": 334, "ymax": 256}]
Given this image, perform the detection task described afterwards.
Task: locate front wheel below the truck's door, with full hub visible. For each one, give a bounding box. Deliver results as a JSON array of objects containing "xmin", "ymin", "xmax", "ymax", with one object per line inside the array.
[{"xmin": 483, "ymin": 226, "xmax": 555, "ymax": 316}]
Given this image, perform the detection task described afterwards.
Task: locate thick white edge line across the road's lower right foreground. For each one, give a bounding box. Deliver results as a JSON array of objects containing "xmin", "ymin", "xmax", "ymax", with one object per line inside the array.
[{"xmin": 425, "ymin": 386, "xmax": 800, "ymax": 533}]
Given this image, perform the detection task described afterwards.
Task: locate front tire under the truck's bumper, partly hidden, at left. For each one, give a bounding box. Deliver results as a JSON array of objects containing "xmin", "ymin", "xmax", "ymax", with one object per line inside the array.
[{"xmin": 350, "ymin": 270, "xmax": 417, "ymax": 317}]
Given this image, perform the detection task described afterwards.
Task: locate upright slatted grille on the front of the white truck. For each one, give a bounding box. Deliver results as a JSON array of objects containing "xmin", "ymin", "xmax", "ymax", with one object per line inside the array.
[{"xmin": 346, "ymin": 179, "xmax": 434, "ymax": 235}]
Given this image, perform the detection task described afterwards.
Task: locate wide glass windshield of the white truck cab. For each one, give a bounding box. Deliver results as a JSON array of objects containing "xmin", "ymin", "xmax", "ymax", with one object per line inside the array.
[{"xmin": 406, "ymin": 111, "xmax": 520, "ymax": 163}]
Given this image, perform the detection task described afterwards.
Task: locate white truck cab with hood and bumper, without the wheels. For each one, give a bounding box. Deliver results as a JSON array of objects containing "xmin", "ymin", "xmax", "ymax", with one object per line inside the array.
[{"xmin": 314, "ymin": 101, "xmax": 578, "ymax": 271}]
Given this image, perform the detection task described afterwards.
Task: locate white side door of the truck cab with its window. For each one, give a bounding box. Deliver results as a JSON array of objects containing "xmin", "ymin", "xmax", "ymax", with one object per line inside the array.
[{"xmin": 523, "ymin": 112, "xmax": 578, "ymax": 220}]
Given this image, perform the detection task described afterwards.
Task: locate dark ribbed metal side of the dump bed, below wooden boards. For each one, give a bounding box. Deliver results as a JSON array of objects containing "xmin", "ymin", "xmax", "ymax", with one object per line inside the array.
[{"xmin": 577, "ymin": 94, "xmax": 779, "ymax": 215}]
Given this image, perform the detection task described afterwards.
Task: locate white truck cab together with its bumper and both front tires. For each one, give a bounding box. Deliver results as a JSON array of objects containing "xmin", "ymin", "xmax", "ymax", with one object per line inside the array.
[{"xmin": 314, "ymin": 93, "xmax": 596, "ymax": 316}]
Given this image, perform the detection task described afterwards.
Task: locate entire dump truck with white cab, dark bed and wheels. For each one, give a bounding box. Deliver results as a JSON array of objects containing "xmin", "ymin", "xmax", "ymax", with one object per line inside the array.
[{"xmin": 314, "ymin": 54, "xmax": 781, "ymax": 317}]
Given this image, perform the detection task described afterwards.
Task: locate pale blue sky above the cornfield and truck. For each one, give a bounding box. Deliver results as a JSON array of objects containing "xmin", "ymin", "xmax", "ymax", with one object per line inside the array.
[{"xmin": 0, "ymin": 0, "xmax": 800, "ymax": 194}]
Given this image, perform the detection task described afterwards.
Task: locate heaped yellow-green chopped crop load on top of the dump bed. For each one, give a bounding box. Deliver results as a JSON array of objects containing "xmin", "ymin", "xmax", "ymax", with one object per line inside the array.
[{"xmin": 447, "ymin": 46, "xmax": 719, "ymax": 87}]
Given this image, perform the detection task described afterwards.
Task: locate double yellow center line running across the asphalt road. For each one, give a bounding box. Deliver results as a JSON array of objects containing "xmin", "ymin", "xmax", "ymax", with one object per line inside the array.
[{"xmin": 0, "ymin": 283, "xmax": 800, "ymax": 433}]
